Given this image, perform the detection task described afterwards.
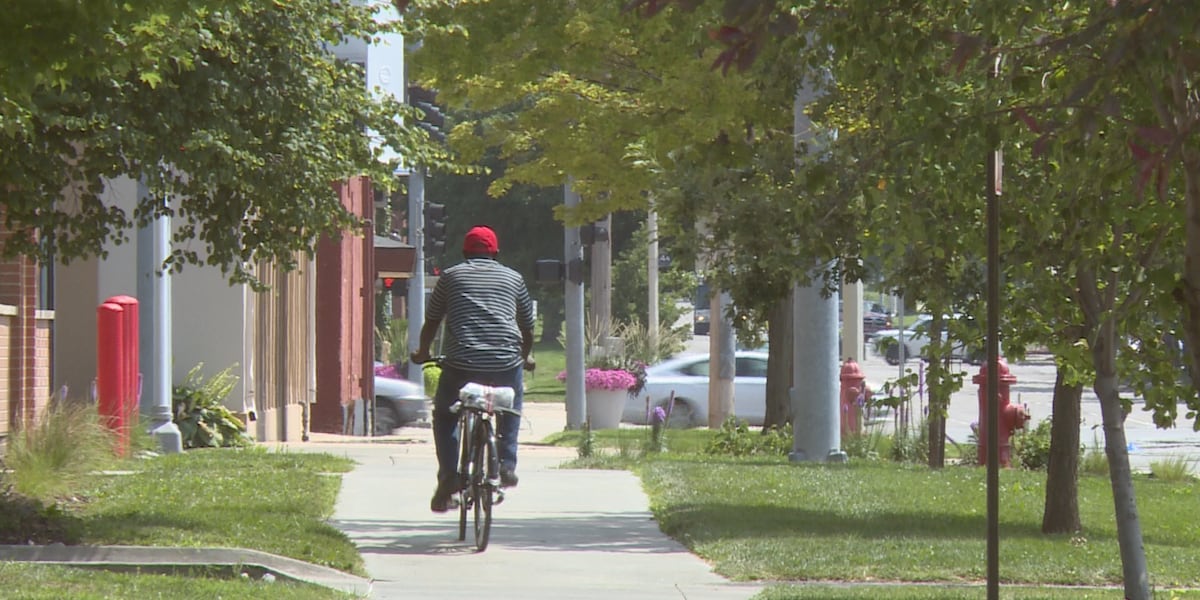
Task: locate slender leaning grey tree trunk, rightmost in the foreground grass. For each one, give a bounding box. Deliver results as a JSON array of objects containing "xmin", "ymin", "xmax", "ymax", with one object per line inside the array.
[{"xmin": 1092, "ymin": 320, "xmax": 1151, "ymax": 600}]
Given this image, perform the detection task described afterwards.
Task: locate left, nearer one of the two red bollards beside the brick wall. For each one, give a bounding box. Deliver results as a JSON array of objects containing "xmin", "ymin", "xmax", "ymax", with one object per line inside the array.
[{"xmin": 96, "ymin": 302, "xmax": 130, "ymax": 456}]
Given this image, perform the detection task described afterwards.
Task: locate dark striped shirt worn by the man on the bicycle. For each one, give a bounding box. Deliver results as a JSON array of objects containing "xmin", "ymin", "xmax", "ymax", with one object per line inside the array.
[{"xmin": 425, "ymin": 257, "xmax": 533, "ymax": 371}]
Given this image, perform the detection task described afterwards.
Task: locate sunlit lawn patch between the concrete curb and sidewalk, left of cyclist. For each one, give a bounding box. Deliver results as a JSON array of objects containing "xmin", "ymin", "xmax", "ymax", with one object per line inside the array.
[{"xmin": 73, "ymin": 448, "xmax": 365, "ymax": 575}]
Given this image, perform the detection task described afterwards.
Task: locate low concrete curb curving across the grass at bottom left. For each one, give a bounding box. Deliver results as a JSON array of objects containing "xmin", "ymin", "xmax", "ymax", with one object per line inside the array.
[{"xmin": 0, "ymin": 544, "xmax": 372, "ymax": 596}]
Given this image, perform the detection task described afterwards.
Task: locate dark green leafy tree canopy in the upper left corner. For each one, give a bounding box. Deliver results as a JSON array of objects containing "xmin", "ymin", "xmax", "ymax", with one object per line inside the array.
[{"xmin": 0, "ymin": 0, "xmax": 446, "ymax": 282}]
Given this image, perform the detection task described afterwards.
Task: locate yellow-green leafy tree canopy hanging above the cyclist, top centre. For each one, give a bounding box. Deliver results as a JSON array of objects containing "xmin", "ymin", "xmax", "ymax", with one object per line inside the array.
[{"xmin": 403, "ymin": 1, "xmax": 809, "ymax": 417}]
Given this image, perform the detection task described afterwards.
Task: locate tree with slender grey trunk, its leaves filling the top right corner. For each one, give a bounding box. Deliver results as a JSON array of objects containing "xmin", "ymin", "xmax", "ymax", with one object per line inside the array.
[{"xmin": 631, "ymin": 0, "xmax": 1200, "ymax": 598}]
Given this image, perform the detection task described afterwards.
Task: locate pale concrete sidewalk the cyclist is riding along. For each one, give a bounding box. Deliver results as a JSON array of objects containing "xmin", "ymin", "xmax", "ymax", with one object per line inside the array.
[{"xmin": 288, "ymin": 404, "xmax": 761, "ymax": 600}]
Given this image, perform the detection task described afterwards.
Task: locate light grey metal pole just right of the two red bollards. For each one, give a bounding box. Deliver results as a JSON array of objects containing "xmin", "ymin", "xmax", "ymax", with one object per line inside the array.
[{"xmin": 138, "ymin": 179, "xmax": 184, "ymax": 454}]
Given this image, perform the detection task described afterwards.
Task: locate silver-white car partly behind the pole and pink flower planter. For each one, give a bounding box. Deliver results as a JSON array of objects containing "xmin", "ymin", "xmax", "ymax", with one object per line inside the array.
[{"xmin": 620, "ymin": 350, "xmax": 767, "ymax": 427}]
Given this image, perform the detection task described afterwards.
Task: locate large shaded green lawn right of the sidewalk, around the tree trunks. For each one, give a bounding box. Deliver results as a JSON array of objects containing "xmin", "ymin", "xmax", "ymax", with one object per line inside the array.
[{"xmin": 637, "ymin": 456, "xmax": 1200, "ymax": 588}]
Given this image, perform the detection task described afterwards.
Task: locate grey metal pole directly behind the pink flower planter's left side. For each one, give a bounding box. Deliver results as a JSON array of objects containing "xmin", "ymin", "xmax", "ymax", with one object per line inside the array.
[{"xmin": 563, "ymin": 178, "xmax": 587, "ymax": 430}]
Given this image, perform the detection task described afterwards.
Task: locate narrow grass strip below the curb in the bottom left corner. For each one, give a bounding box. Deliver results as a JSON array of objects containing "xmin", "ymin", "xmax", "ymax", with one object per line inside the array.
[{"xmin": 0, "ymin": 563, "xmax": 355, "ymax": 600}]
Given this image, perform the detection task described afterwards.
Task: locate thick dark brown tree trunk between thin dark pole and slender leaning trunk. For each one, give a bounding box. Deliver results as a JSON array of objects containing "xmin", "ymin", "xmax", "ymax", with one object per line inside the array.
[{"xmin": 1042, "ymin": 370, "xmax": 1084, "ymax": 533}]
